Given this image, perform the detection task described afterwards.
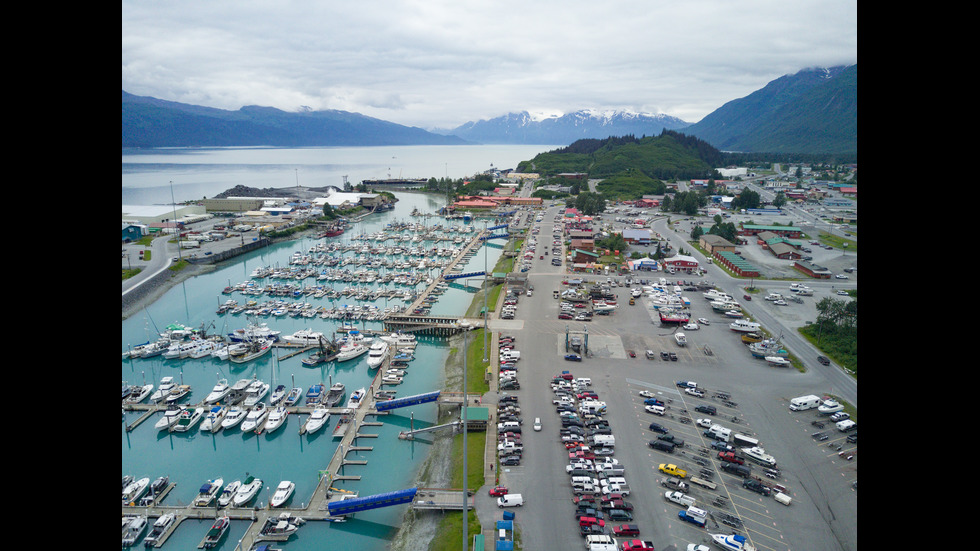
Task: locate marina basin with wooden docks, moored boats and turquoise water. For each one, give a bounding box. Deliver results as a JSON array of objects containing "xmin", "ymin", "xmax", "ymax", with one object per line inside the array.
[{"xmin": 123, "ymin": 189, "xmax": 501, "ymax": 550}]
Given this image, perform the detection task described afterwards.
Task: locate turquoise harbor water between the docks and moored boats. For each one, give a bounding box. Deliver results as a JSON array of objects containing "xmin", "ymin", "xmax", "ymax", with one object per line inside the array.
[{"xmin": 120, "ymin": 193, "xmax": 501, "ymax": 551}]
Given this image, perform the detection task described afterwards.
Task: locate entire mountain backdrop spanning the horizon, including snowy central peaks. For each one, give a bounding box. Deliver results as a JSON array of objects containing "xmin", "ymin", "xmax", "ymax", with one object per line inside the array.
[{"xmin": 122, "ymin": 65, "xmax": 857, "ymax": 154}]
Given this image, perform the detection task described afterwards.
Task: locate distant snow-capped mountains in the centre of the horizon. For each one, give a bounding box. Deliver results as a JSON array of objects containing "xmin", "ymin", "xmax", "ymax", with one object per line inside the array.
[{"xmin": 435, "ymin": 109, "xmax": 690, "ymax": 144}]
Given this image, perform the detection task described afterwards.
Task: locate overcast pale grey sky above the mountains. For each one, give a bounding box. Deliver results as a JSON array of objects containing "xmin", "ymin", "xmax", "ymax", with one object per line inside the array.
[{"xmin": 122, "ymin": 0, "xmax": 857, "ymax": 129}]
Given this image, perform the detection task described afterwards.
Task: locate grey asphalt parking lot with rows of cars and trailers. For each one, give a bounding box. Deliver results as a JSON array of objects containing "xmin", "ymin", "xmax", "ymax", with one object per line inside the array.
[{"xmin": 492, "ymin": 205, "xmax": 857, "ymax": 550}]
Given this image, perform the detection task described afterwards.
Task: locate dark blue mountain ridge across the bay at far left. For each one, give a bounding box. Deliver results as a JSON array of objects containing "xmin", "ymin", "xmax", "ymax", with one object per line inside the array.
[{"xmin": 122, "ymin": 91, "xmax": 467, "ymax": 147}]
